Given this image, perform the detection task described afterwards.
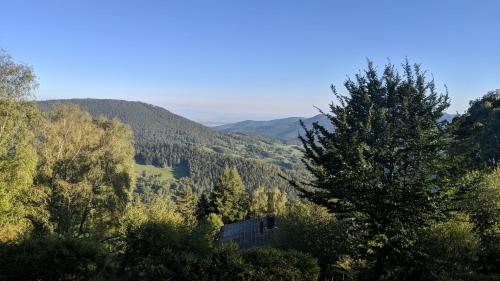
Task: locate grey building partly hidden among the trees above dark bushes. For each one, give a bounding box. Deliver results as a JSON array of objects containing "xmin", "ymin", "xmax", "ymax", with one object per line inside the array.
[{"xmin": 222, "ymin": 216, "xmax": 278, "ymax": 249}]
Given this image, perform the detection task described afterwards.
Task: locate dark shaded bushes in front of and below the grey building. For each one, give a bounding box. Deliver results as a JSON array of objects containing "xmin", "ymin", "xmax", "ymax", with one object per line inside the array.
[{"xmin": 121, "ymin": 223, "xmax": 319, "ymax": 280}]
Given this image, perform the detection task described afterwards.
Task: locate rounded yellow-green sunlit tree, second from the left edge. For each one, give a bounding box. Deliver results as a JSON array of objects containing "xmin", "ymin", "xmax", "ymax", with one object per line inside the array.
[{"xmin": 36, "ymin": 105, "xmax": 134, "ymax": 239}]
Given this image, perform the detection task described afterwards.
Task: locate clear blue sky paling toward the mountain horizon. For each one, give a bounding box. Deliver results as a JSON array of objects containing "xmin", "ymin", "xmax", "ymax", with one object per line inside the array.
[{"xmin": 0, "ymin": 0, "xmax": 500, "ymax": 122}]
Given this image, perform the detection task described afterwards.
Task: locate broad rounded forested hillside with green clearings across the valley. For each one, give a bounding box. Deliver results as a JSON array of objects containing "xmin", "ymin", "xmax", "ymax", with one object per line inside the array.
[{"xmin": 38, "ymin": 99, "xmax": 301, "ymax": 192}]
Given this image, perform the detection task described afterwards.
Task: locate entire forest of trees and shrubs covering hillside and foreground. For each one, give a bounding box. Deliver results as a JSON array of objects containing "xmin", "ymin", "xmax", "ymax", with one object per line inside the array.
[{"xmin": 0, "ymin": 52, "xmax": 500, "ymax": 281}]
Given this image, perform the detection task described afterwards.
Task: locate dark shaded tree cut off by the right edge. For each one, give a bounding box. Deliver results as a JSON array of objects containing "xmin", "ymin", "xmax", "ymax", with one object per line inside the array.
[{"xmin": 451, "ymin": 90, "xmax": 500, "ymax": 169}]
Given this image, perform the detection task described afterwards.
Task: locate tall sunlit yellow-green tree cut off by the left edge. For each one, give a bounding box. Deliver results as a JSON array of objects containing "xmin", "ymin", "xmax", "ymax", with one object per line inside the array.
[{"xmin": 0, "ymin": 50, "xmax": 43, "ymax": 242}]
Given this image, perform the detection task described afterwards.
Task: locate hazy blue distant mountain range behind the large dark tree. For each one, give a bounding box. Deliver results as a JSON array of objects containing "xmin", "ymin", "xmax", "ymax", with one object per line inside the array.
[{"xmin": 213, "ymin": 113, "xmax": 455, "ymax": 143}]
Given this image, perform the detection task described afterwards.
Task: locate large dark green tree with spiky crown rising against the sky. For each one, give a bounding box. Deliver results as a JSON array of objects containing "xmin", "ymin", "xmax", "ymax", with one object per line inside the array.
[{"xmin": 295, "ymin": 59, "xmax": 449, "ymax": 279}]
